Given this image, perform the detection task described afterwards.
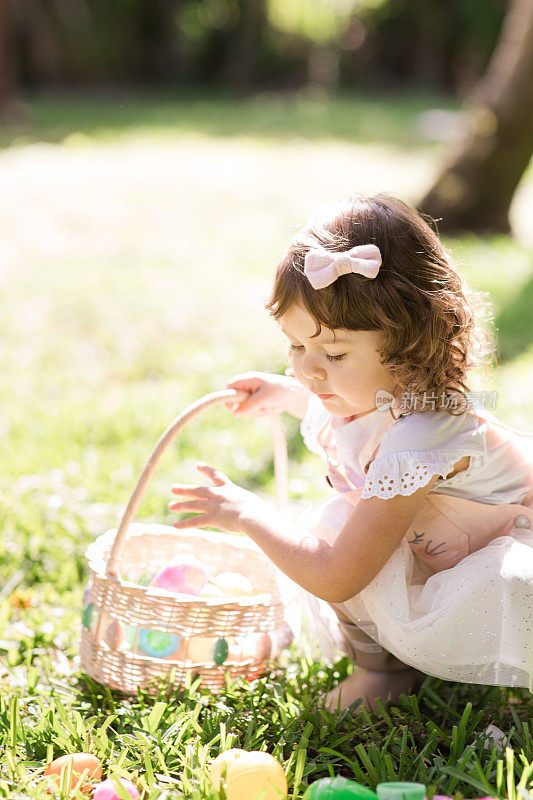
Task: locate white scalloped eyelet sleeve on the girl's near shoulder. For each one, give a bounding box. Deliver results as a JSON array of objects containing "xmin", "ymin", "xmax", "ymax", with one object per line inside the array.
[{"xmin": 361, "ymin": 411, "xmax": 486, "ymax": 499}]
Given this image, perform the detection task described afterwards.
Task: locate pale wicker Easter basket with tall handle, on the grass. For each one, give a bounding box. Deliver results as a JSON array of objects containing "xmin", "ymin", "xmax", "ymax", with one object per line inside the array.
[{"xmin": 80, "ymin": 389, "xmax": 290, "ymax": 693}]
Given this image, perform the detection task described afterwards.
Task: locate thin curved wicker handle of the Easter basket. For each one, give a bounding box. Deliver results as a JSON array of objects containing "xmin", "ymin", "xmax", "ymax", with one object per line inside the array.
[{"xmin": 106, "ymin": 389, "xmax": 288, "ymax": 578}]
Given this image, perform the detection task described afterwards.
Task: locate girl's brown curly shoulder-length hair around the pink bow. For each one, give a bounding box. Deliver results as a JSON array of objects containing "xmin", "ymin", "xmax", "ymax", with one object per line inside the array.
[{"xmin": 265, "ymin": 194, "xmax": 495, "ymax": 414}]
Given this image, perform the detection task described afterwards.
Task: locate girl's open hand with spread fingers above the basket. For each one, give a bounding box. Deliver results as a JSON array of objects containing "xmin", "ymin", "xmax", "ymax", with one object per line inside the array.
[{"xmin": 168, "ymin": 463, "xmax": 263, "ymax": 533}]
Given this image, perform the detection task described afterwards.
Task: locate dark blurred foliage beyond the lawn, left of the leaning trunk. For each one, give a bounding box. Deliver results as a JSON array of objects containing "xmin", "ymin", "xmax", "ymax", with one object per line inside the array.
[{"xmin": 7, "ymin": 0, "xmax": 506, "ymax": 92}]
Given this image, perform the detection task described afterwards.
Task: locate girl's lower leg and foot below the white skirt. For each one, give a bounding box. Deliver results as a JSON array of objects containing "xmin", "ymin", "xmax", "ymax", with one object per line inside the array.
[{"xmin": 325, "ymin": 605, "xmax": 426, "ymax": 711}]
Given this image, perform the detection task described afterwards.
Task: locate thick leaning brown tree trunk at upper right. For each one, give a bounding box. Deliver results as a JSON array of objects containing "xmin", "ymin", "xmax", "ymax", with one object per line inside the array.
[{"xmin": 419, "ymin": 0, "xmax": 533, "ymax": 233}]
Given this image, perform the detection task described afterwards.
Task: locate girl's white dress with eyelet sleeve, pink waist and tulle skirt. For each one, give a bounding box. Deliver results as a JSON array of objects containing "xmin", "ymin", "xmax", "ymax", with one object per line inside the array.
[{"xmin": 284, "ymin": 396, "xmax": 533, "ymax": 691}]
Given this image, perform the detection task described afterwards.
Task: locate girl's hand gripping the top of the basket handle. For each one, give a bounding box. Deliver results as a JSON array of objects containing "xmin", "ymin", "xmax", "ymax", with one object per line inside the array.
[{"xmin": 226, "ymin": 372, "xmax": 309, "ymax": 419}]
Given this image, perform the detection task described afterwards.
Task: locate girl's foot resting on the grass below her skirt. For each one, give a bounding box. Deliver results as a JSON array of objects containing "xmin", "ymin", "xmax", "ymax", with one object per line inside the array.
[{"xmin": 324, "ymin": 666, "xmax": 426, "ymax": 711}]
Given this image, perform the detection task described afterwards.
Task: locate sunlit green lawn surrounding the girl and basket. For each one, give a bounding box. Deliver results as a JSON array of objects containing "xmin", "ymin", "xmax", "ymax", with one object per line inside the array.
[{"xmin": 0, "ymin": 93, "xmax": 533, "ymax": 800}]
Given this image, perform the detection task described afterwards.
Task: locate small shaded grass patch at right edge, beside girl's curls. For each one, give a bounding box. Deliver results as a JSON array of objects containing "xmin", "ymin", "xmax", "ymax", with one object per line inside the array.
[{"xmin": 495, "ymin": 278, "xmax": 533, "ymax": 364}]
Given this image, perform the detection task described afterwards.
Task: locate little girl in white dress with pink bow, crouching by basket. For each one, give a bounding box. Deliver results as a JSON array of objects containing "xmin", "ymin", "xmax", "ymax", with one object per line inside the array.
[{"xmin": 170, "ymin": 195, "xmax": 533, "ymax": 709}]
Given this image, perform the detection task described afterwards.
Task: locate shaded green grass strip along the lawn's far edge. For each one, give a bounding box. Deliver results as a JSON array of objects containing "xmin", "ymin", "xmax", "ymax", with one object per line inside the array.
[{"xmin": 0, "ymin": 87, "xmax": 457, "ymax": 149}]
